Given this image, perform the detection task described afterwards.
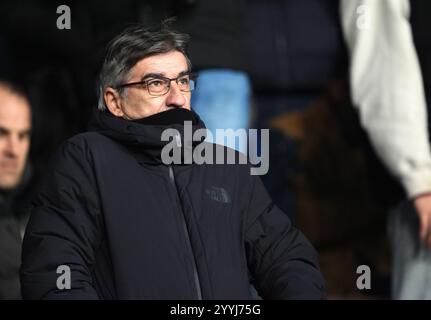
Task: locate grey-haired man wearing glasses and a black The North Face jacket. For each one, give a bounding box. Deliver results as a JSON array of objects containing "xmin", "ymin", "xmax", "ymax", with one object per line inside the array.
[{"xmin": 21, "ymin": 25, "xmax": 325, "ymax": 299}]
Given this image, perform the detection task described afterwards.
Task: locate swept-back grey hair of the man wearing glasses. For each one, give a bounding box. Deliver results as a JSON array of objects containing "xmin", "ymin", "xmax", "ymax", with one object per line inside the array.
[{"xmin": 98, "ymin": 19, "xmax": 192, "ymax": 111}]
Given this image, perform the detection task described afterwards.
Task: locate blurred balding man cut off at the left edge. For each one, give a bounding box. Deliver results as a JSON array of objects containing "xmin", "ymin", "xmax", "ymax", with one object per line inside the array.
[{"xmin": 0, "ymin": 81, "xmax": 31, "ymax": 299}]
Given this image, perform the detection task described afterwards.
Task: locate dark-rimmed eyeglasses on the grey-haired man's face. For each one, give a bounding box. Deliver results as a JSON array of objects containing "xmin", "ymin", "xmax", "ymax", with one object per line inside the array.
[{"xmin": 116, "ymin": 73, "xmax": 197, "ymax": 97}]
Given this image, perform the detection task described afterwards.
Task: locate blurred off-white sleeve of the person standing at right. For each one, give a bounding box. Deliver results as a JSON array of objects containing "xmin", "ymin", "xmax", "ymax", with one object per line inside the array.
[{"xmin": 340, "ymin": 0, "xmax": 431, "ymax": 197}]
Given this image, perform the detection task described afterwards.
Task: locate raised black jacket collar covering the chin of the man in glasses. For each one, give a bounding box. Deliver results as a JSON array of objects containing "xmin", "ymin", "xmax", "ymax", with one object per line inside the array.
[{"xmin": 89, "ymin": 108, "xmax": 205, "ymax": 165}]
